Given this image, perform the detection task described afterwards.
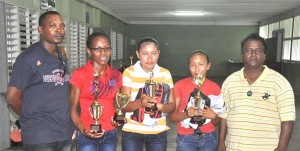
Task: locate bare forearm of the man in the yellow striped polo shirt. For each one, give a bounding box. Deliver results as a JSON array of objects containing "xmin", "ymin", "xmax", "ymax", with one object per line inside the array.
[{"xmin": 275, "ymin": 121, "xmax": 294, "ymax": 151}]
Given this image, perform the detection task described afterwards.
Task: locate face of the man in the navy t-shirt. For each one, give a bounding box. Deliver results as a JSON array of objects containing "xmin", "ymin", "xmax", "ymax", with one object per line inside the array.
[{"xmin": 38, "ymin": 14, "xmax": 65, "ymax": 45}]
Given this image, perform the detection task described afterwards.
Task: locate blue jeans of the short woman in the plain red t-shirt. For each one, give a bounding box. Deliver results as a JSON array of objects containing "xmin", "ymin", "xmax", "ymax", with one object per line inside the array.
[{"xmin": 176, "ymin": 131, "xmax": 218, "ymax": 151}]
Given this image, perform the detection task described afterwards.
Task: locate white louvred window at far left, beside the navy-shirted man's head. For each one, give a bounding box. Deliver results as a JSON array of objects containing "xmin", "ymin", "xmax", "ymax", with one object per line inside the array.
[{"xmin": 3, "ymin": 3, "xmax": 39, "ymax": 75}]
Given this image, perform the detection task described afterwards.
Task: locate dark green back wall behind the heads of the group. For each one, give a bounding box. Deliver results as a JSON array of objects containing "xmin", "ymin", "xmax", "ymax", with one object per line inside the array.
[{"xmin": 126, "ymin": 25, "xmax": 258, "ymax": 77}]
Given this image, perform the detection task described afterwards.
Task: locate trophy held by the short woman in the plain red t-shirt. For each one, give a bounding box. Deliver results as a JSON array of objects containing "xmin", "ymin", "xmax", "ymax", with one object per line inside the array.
[{"xmin": 190, "ymin": 73, "xmax": 205, "ymax": 126}]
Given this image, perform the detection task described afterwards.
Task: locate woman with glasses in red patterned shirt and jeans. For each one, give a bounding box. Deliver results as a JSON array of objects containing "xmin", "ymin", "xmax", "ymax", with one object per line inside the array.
[{"xmin": 70, "ymin": 33, "xmax": 122, "ymax": 151}]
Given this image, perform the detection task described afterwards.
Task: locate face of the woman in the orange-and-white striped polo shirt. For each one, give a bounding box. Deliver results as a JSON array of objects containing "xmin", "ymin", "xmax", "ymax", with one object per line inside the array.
[{"xmin": 136, "ymin": 42, "xmax": 159, "ymax": 72}]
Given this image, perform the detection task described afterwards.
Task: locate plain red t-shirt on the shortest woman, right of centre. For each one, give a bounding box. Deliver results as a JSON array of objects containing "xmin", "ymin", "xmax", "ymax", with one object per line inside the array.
[{"xmin": 174, "ymin": 77, "xmax": 221, "ymax": 135}]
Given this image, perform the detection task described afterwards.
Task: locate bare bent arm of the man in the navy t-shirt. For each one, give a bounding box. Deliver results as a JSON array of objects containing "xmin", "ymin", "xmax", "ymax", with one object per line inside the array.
[{"xmin": 6, "ymin": 86, "xmax": 23, "ymax": 115}]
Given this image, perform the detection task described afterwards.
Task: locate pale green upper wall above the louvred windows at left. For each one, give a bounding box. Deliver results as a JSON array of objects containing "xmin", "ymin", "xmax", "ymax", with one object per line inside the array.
[{"xmin": 3, "ymin": 0, "xmax": 126, "ymax": 32}]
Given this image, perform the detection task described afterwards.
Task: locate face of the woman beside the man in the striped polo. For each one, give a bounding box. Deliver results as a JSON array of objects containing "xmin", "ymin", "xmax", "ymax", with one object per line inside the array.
[{"xmin": 189, "ymin": 53, "xmax": 210, "ymax": 77}]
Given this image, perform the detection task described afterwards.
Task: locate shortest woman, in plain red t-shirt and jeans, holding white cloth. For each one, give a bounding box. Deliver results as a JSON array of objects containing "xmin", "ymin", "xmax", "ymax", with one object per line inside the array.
[{"xmin": 170, "ymin": 50, "xmax": 224, "ymax": 151}]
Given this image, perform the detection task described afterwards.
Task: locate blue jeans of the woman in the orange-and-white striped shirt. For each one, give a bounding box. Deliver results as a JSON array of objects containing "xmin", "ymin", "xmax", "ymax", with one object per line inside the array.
[{"xmin": 122, "ymin": 131, "xmax": 167, "ymax": 151}]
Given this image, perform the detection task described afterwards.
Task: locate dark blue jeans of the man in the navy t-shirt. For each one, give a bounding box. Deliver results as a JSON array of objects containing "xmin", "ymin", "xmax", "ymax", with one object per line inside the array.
[{"xmin": 24, "ymin": 138, "xmax": 72, "ymax": 151}]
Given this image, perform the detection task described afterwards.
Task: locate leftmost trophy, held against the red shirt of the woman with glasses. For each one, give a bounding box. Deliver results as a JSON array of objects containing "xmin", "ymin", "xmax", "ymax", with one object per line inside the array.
[{"xmin": 89, "ymin": 74, "xmax": 103, "ymax": 133}]
